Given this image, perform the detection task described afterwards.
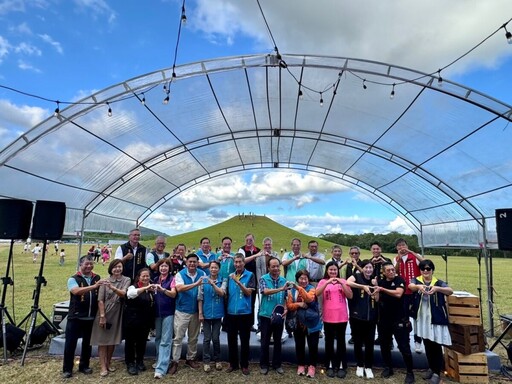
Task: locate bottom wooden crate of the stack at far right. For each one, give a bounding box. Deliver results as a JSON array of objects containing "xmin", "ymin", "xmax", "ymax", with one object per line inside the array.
[{"xmin": 444, "ymin": 347, "xmax": 489, "ymax": 384}]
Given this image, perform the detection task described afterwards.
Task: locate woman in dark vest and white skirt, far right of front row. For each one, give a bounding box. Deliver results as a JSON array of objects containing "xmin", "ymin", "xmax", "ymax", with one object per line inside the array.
[{"xmin": 409, "ymin": 259, "xmax": 453, "ymax": 384}]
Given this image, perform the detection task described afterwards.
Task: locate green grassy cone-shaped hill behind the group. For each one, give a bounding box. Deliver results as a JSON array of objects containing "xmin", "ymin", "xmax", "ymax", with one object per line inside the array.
[{"xmin": 160, "ymin": 215, "xmax": 340, "ymax": 256}]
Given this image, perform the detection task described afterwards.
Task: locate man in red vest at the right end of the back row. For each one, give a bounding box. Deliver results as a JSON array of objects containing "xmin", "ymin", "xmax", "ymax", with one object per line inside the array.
[{"xmin": 393, "ymin": 238, "xmax": 424, "ymax": 353}]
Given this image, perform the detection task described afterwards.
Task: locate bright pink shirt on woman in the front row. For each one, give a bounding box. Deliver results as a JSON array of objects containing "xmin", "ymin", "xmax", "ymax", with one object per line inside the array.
[{"xmin": 316, "ymin": 279, "xmax": 348, "ymax": 323}]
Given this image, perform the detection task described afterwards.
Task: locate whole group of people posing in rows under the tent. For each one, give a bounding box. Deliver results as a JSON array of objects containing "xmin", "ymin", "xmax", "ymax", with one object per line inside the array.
[{"xmin": 63, "ymin": 229, "xmax": 453, "ymax": 384}]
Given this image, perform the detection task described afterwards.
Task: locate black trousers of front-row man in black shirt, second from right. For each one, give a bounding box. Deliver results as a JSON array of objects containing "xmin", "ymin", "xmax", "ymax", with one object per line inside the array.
[{"xmin": 378, "ymin": 320, "xmax": 413, "ymax": 372}]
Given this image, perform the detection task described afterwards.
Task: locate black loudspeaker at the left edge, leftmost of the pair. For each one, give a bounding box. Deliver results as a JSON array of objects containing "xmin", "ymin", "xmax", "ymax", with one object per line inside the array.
[{"xmin": 0, "ymin": 199, "xmax": 33, "ymax": 239}]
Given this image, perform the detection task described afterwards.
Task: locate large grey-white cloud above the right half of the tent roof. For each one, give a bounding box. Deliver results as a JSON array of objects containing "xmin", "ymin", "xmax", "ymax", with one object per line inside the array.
[{"xmin": 196, "ymin": 0, "xmax": 512, "ymax": 72}]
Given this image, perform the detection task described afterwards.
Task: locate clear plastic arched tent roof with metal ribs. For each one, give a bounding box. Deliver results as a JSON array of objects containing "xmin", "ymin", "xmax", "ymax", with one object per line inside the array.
[{"xmin": 0, "ymin": 55, "xmax": 512, "ymax": 246}]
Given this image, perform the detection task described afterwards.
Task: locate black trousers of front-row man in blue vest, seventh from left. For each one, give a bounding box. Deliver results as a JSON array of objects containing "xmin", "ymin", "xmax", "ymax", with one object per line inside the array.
[{"xmin": 224, "ymin": 313, "xmax": 254, "ymax": 369}]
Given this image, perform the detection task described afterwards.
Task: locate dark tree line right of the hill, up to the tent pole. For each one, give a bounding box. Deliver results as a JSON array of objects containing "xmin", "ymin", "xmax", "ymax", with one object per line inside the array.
[{"xmin": 318, "ymin": 232, "xmax": 420, "ymax": 253}]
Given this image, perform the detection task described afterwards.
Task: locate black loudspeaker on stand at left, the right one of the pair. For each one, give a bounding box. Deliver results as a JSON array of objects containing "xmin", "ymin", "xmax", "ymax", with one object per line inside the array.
[{"xmin": 32, "ymin": 200, "xmax": 66, "ymax": 240}]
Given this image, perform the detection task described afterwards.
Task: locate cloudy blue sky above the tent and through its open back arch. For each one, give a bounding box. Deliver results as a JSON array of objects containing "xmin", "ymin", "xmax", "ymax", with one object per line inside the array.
[{"xmin": 0, "ymin": 0, "xmax": 512, "ymax": 235}]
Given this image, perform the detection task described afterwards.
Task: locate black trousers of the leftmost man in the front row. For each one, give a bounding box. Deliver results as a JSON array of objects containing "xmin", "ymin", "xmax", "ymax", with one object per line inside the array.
[{"xmin": 62, "ymin": 319, "xmax": 94, "ymax": 372}]
